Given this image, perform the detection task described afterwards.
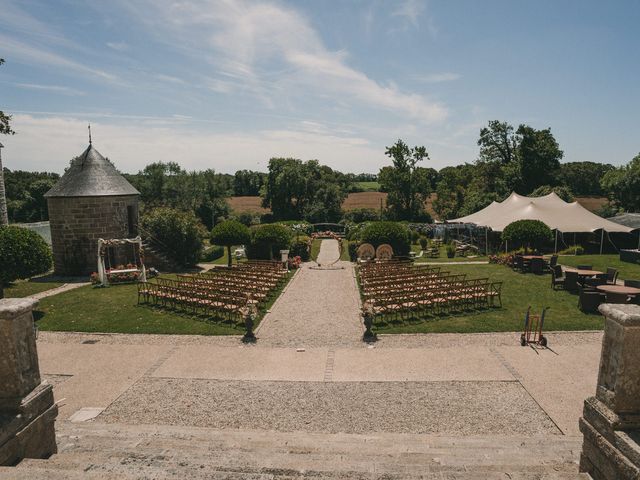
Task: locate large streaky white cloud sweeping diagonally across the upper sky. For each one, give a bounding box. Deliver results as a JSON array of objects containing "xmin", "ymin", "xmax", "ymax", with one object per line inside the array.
[{"xmin": 122, "ymin": 0, "xmax": 448, "ymax": 122}]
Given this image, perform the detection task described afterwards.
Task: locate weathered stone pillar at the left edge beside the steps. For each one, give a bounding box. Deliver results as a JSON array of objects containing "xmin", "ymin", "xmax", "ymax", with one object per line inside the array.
[{"xmin": 0, "ymin": 298, "xmax": 58, "ymax": 465}]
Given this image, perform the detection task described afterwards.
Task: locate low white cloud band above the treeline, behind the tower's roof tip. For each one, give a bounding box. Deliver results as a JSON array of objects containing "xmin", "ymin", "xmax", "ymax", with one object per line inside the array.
[{"xmin": 3, "ymin": 114, "xmax": 387, "ymax": 173}]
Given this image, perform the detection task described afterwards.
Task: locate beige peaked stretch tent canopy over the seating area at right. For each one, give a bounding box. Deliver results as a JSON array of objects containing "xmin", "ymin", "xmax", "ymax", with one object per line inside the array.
[{"xmin": 449, "ymin": 192, "xmax": 633, "ymax": 233}]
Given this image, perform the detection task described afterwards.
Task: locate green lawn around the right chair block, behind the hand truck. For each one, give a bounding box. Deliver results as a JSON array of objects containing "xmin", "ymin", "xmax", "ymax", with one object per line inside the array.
[{"xmin": 375, "ymin": 264, "xmax": 603, "ymax": 333}]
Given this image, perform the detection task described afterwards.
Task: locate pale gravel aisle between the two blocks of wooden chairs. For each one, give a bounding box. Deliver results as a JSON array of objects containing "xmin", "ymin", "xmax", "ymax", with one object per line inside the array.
[{"xmin": 256, "ymin": 251, "xmax": 363, "ymax": 347}]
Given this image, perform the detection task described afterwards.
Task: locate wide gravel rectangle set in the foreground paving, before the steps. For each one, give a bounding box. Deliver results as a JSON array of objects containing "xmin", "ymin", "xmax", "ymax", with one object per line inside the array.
[{"xmin": 99, "ymin": 378, "xmax": 560, "ymax": 435}]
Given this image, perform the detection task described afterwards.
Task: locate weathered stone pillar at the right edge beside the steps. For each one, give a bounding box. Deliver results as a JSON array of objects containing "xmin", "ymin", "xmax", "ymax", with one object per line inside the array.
[{"xmin": 580, "ymin": 304, "xmax": 640, "ymax": 480}]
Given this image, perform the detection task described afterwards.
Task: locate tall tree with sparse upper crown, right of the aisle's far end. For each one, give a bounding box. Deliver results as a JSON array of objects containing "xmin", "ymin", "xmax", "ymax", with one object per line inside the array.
[{"xmin": 378, "ymin": 140, "xmax": 431, "ymax": 220}]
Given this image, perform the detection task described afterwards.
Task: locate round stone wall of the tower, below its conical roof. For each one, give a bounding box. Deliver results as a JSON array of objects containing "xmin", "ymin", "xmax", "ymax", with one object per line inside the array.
[{"xmin": 48, "ymin": 195, "xmax": 138, "ymax": 275}]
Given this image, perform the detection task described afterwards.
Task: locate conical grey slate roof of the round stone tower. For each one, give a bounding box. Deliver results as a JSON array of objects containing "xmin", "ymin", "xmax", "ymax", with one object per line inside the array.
[{"xmin": 44, "ymin": 144, "xmax": 140, "ymax": 198}]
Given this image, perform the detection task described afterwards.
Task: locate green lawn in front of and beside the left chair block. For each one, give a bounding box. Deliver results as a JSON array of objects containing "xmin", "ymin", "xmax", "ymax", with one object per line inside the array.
[{"xmin": 35, "ymin": 272, "xmax": 293, "ymax": 335}]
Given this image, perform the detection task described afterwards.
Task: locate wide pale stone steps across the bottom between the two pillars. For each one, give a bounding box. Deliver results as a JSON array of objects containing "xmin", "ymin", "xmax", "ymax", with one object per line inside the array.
[{"xmin": 0, "ymin": 422, "xmax": 590, "ymax": 480}]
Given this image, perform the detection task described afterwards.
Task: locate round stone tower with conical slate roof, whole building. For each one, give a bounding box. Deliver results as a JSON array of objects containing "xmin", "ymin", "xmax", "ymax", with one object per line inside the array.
[{"xmin": 45, "ymin": 143, "xmax": 140, "ymax": 275}]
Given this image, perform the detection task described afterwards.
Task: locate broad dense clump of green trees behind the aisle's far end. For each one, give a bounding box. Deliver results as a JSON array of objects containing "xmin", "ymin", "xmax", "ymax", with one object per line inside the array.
[{"xmin": 262, "ymin": 158, "xmax": 349, "ymax": 223}]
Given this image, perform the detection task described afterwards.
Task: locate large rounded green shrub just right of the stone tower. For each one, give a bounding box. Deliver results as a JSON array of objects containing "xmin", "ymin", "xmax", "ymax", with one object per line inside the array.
[{"xmin": 141, "ymin": 207, "xmax": 207, "ymax": 265}]
